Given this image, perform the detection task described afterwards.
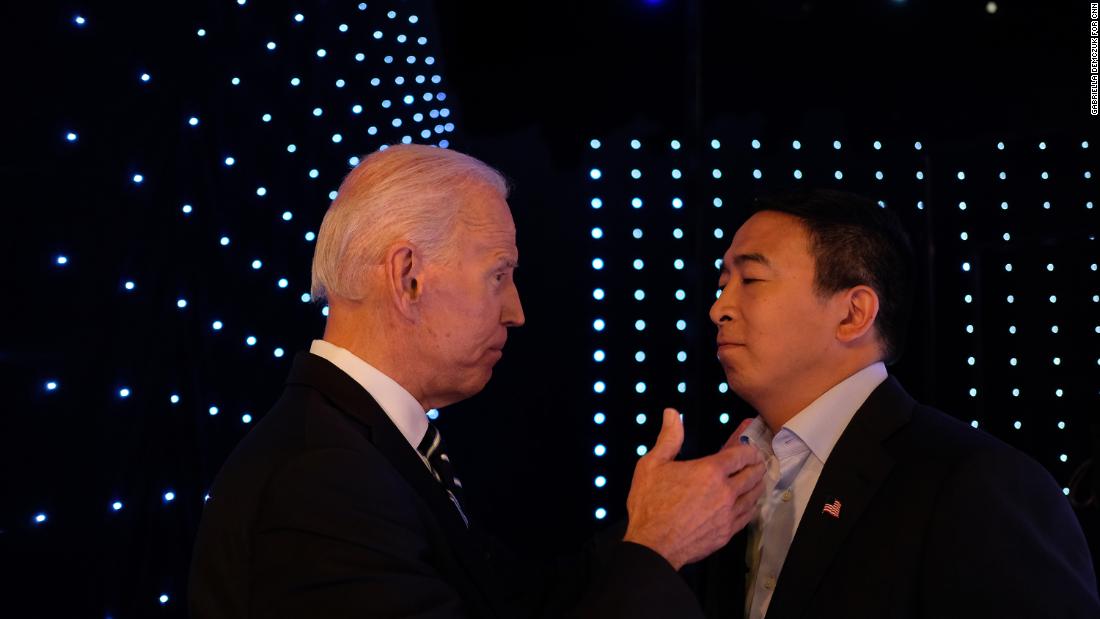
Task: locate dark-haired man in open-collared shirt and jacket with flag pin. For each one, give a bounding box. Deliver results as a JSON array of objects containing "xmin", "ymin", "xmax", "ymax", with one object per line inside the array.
[{"xmin": 697, "ymin": 190, "xmax": 1100, "ymax": 619}]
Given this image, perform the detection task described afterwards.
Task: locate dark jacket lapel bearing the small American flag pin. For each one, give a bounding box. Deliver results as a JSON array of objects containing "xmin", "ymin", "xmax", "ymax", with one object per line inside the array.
[{"xmin": 768, "ymin": 377, "xmax": 915, "ymax": 619}]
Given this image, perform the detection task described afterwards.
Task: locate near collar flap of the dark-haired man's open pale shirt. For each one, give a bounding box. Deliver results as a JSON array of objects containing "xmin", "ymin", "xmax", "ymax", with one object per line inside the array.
[{"xmin": 783, "ymin": 362, "xmax": 887, "ymax": 462}]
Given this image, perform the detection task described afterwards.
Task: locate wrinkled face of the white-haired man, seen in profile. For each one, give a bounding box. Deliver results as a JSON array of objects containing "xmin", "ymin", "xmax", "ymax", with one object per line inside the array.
[{"xmin": 420, "ymin": 186, "xmax": 524, "ymax": 406}]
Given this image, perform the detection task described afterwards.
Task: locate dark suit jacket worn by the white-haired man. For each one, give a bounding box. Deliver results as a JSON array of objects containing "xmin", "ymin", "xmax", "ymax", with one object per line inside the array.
[{"xmin": 189, "ymin": 353, "xmax": 702, "ymax": 619}]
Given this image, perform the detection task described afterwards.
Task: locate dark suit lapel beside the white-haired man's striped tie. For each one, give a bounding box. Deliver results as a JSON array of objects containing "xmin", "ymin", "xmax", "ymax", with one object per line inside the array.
[{"xmin": 287, "ymin": 353, "xmax": 503, "ymax": 615}]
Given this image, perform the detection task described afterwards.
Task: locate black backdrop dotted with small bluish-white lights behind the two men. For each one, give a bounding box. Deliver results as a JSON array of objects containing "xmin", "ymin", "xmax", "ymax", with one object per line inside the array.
[{"xmin": 0, "ymin": 0, "xmax": 1100, "ymax": 617}]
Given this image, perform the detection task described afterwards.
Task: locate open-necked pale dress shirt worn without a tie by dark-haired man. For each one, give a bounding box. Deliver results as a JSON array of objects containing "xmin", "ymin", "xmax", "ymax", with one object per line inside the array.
[{"xmin": 745, "ymin": 362, "xmax": 887, "ymax": 619}]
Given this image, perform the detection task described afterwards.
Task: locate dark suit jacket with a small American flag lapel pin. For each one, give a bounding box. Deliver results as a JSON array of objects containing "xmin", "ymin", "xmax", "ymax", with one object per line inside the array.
[{"xmin": 695, "ymin": 377, "xmax": 1100, "ymax": 619}]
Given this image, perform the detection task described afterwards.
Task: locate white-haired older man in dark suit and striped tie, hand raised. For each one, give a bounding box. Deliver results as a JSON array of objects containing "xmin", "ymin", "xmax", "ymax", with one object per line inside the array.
[{"xmin": 190, "ymin": 145, "xmax": 763, "ymax": 618}]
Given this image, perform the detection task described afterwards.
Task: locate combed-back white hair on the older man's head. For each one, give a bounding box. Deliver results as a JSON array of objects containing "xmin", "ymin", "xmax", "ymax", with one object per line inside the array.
[{"xmin": 310, "ymin": 144, "xmax": 508, "ymax": 300}]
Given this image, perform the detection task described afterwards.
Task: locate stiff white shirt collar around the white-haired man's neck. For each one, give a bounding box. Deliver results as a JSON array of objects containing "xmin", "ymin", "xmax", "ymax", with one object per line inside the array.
[{"xmin": 309, "ymin": 340, "xmax": 428, "ymax": 449}]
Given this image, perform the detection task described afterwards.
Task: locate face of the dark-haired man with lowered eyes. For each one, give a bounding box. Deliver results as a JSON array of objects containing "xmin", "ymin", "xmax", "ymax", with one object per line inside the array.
[{"xmin": 711, "ymin": 211, "xmax": 837, "ymax": 408}]
